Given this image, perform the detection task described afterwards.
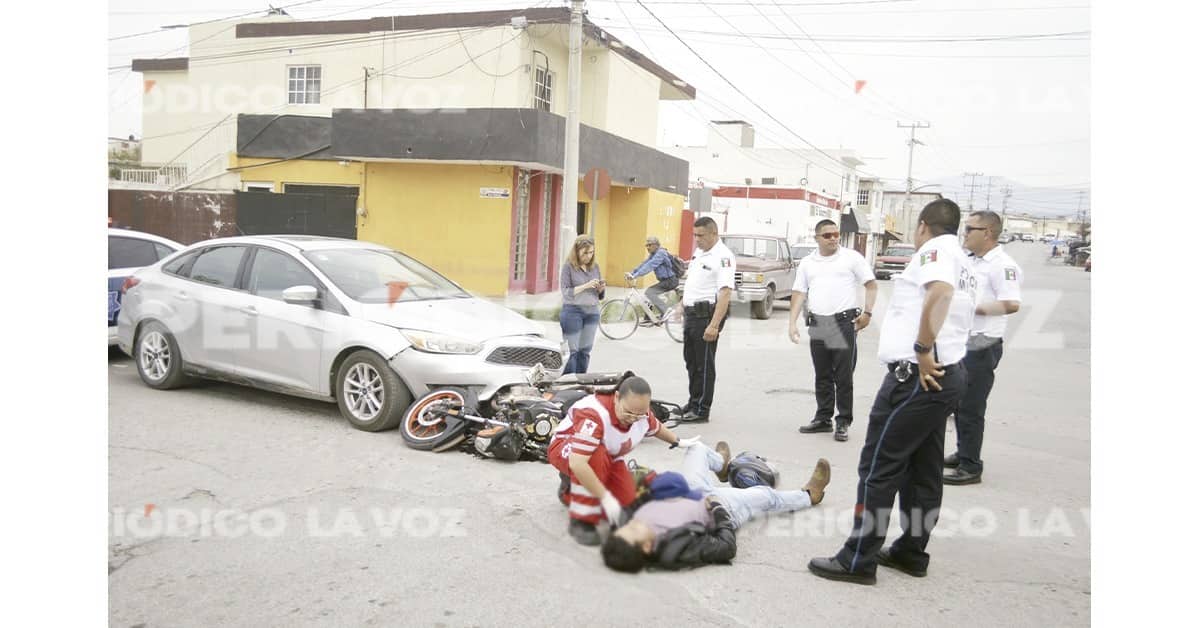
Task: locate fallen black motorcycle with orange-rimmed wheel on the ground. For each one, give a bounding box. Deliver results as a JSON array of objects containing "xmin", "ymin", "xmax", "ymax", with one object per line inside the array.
[{"xmin": 400, "ymin": 364, "xmax": 683, "ymax": 462}]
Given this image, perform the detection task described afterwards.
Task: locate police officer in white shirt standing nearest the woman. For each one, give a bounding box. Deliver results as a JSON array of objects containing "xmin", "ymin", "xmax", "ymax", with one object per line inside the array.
[{"xmin": 679, "ymin": 216, "xmax": 738, "ymax": 423}]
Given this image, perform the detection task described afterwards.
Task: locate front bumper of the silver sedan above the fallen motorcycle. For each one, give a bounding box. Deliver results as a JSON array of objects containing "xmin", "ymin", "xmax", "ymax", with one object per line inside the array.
[{"xmin": 389, "ymin": 336, "xmax": 565, "ymax": 400}]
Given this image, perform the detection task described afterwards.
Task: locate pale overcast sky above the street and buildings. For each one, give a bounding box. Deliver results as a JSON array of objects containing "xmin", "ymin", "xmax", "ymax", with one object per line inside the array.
[{"xmin": 108, "ymin": 0, "xmax": 1091, "ymax": 214}]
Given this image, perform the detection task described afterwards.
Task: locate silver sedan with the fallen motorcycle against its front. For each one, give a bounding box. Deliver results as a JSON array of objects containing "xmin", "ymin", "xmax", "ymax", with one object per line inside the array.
[{"xmin": 118, "ymin": 235, "xmax": 563, "ymax": 431}]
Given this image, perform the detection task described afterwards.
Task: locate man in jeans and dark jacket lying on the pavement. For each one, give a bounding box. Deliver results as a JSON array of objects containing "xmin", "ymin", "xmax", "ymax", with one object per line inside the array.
[{"xmin": 601, "ymin": 441, "xmax": 829, "ymax": 573}]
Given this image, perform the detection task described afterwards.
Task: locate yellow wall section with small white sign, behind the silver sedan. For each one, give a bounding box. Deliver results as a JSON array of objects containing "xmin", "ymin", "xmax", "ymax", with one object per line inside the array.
[{"xmin": 358, "ymin": 163, "xmax": 515, "ymax": 295}]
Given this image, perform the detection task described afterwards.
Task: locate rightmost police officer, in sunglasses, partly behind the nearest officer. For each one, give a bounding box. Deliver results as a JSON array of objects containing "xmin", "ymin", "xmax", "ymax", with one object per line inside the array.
[{"xmin": 942, "ymin": 211, "xmax": 1024, "ymax": 485}]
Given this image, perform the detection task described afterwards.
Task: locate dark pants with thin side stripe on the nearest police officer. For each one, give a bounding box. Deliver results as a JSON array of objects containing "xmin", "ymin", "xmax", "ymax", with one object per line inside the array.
[{"xmin": 838, "ymin": 364, "xmax": 966, "ymax": 573}]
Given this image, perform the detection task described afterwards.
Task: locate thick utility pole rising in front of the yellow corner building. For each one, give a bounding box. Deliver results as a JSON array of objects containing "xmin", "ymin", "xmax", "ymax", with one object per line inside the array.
[{"xmin": 559, "ymin": 0, "xmax": 583, "ymax": 268}]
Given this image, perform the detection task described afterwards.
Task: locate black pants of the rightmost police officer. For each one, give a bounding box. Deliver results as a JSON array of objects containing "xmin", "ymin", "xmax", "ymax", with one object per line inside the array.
[{"xmin": 954, "ymin": 336, "xmax": 1004, "ymax": 473}]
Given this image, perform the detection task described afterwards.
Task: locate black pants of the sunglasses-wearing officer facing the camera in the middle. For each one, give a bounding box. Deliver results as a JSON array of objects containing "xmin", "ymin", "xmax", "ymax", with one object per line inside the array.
[{"xmin": 809, "ymin": 316, "xmax": 858, "ymax": 425}]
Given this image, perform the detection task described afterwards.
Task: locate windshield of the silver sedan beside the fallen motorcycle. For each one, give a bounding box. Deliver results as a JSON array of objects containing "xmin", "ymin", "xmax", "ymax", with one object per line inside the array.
[{"xmin": 304, "ymin": 249, "xmax": 470, "ymax": 303}]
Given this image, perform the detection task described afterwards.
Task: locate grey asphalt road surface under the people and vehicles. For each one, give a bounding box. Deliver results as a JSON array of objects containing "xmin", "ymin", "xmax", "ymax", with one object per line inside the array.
[{"xmin": 109, "ymin": 243, "xmax": 1091, "ymax": 627}]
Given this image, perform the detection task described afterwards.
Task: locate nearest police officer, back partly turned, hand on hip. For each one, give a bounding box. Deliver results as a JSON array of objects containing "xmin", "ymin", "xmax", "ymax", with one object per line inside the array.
[{"xmin": 809, "ymin": 199, "xmax": 976, "ymax": 585}]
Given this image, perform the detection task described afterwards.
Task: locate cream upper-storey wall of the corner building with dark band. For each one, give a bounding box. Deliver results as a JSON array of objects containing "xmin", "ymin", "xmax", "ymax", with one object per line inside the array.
[{"xmin": 143, "ymin": 18, "xmax": 676, "ymax": 184}]
